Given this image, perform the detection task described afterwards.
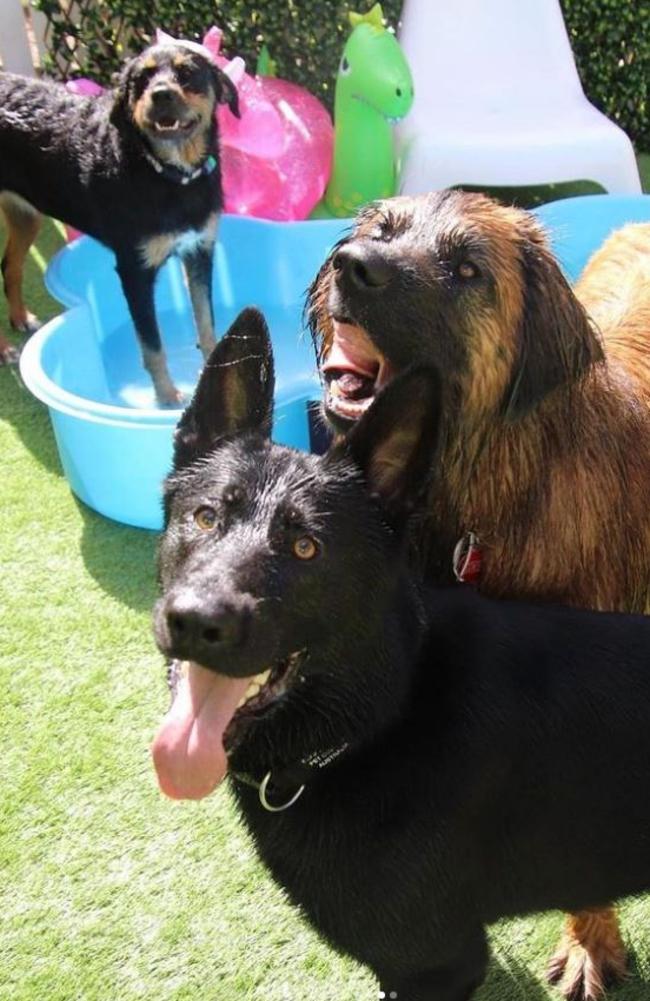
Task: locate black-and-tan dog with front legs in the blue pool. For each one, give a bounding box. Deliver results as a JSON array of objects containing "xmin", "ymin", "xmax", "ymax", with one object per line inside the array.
[{"xmin": 0, "ymin": 42, "xmax": 238, "ymax": 404}]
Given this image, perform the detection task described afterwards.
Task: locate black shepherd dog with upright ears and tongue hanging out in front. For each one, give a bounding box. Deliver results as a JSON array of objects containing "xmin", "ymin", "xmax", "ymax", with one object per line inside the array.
[{"xmin": 153, "ymin": 311, "xmax": 650, "ymax": 1001}]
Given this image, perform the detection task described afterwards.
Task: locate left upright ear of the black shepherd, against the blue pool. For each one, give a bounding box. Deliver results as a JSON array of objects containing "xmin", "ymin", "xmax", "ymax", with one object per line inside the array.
[{"xmin": 173, "ymin": 308, "xmax": 274, "ymax": 469}]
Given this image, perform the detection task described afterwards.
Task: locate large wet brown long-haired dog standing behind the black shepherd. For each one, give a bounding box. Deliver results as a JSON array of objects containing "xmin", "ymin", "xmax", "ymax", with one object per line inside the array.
[{"xmin": 308, "ymin": 191, "xmax": 650, "ymax": 1001}]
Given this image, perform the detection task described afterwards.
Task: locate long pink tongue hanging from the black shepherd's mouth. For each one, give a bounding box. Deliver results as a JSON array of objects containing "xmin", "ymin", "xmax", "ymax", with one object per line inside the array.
[{"xmin": 151, "ymin": 664, "xmax": 250, "ymax": 800}]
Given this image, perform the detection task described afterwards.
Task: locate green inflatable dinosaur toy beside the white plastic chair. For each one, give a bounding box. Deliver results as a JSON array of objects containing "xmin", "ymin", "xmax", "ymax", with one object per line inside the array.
[{"xmin": 311, "ymin": 3, "xmax": 413, "ymax": 218}]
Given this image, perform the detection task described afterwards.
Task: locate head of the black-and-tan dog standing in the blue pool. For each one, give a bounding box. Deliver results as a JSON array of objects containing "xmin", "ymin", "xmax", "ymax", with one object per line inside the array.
[{"xmin": 112, "ymin": 41, "xmax": 238, "ymax": 167}]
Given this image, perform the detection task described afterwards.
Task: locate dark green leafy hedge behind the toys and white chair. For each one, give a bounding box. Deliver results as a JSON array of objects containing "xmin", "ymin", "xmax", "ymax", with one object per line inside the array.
[{"xmin": 32, "ymin": 0, "xmax": 650, "ymax": 150}]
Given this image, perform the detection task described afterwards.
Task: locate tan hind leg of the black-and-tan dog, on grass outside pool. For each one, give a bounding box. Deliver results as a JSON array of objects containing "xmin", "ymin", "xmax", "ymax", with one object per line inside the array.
[{"xmin": 0, "ymin": 191, "xmax": 41, "ymax": 336}]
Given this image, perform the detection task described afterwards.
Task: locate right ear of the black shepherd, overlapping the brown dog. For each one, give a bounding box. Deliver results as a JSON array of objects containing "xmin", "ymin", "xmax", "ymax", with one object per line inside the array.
[{"xmin": 340, "ymin": 365, "xmax": 442, "ymax": 515}]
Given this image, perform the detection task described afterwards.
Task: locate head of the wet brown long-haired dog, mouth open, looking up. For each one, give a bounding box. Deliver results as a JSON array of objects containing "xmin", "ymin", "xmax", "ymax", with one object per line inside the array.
[{"xmin": 307, "ymin": 191, "xmax": 602, "ymax": 429}]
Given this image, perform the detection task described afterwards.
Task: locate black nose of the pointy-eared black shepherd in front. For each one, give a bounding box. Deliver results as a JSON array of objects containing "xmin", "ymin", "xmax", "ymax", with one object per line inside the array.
[{"xmin": 165, "ymin": 594, "xmax": 250, "ymax": 660}]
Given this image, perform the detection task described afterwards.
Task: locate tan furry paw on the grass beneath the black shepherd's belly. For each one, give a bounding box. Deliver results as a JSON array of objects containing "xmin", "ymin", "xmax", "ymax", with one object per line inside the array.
[{"xmin": 548, "ymin": 907, "xmax": 626, "ymax": 1001}]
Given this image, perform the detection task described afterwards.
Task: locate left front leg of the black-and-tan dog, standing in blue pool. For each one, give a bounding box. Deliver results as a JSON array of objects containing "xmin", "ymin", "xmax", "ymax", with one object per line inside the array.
[{"xmin": 117, "ymin": 255, "xmax": 182, "ymax": 406}]
